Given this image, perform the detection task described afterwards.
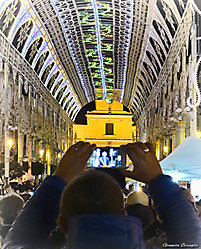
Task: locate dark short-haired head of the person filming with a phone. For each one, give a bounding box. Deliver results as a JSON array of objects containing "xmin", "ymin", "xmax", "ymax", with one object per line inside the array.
[{"xmin": 58, "ymin": 169, "xmax": 124, "ymax": 232}]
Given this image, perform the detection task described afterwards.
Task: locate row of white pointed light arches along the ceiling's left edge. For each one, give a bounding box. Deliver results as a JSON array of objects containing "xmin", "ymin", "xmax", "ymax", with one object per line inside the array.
[{"xmin": 0, "ymin": 0, "xmax": 80, "ymax": 115}]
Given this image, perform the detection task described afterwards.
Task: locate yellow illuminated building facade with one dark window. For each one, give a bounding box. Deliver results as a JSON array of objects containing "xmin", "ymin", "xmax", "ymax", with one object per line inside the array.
[{"xmin": 73, "ymin": 100, "xmax": 135, "ymax": 147}]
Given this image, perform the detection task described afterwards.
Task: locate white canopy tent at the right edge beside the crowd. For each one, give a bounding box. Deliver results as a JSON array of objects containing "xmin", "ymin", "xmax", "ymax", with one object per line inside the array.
[{"xmin": 160, "ymin": 135, "xmax": 201, "ymax": 179}]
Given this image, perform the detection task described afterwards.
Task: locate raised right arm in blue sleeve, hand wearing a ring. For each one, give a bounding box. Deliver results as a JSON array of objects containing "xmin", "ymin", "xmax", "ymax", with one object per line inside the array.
[{"xmin": 122, "ymin": 143, "xmax": 201, "ymax": 247}]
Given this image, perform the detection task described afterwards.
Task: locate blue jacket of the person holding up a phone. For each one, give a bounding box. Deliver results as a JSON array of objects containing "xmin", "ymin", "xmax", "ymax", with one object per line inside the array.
[{"xmin": 3, "ymin": 175, "xmax": 201, "ymax": 249}]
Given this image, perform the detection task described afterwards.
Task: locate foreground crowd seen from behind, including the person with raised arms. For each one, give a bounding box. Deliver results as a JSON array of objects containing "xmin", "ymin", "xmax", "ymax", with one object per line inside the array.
[{"xmin": 0, "ymin": 142, "xmax": 201, "ymax": 249}]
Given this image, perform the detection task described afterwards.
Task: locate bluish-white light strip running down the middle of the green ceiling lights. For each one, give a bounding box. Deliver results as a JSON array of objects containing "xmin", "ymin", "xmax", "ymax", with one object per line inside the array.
[{"xmin": 91, "ymin": 0, "xmax": 107, "ymax": 99}]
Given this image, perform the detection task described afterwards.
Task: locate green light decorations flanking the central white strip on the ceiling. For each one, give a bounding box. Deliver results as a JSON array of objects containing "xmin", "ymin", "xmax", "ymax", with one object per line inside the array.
[{"xmin": 79, "ymin": 0, "xmax": 114, "ymax": 98}]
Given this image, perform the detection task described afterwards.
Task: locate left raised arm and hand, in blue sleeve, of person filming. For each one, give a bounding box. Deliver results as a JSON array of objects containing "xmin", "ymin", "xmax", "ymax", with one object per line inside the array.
[{"xmin": 3, "ymin": 142, "xmax": 95, "ymax": 249}]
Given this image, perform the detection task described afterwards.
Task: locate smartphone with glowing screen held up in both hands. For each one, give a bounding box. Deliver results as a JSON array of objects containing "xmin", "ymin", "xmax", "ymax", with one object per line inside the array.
[{"xmin": 87, "ymin": 147, "xmax": 126, "ymax": 168}]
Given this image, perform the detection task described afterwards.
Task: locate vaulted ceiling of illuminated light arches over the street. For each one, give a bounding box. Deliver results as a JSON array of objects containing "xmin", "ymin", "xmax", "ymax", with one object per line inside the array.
[{"xmin": 1, "ymin": 0, "xmax": 192, "ymax": 118}]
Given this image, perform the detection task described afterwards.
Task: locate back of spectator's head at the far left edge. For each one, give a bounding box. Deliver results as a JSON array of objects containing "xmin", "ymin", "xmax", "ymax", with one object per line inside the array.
[{"xmin": 0, "ymin": 193, "xmax": 24, "ymax": 224}]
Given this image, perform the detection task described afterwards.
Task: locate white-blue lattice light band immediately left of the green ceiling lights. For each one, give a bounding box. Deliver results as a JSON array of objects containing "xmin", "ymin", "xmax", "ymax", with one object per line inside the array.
[{"xmin": 54, "ymin": 0, "xmax": 95, "ymax": 101}]
